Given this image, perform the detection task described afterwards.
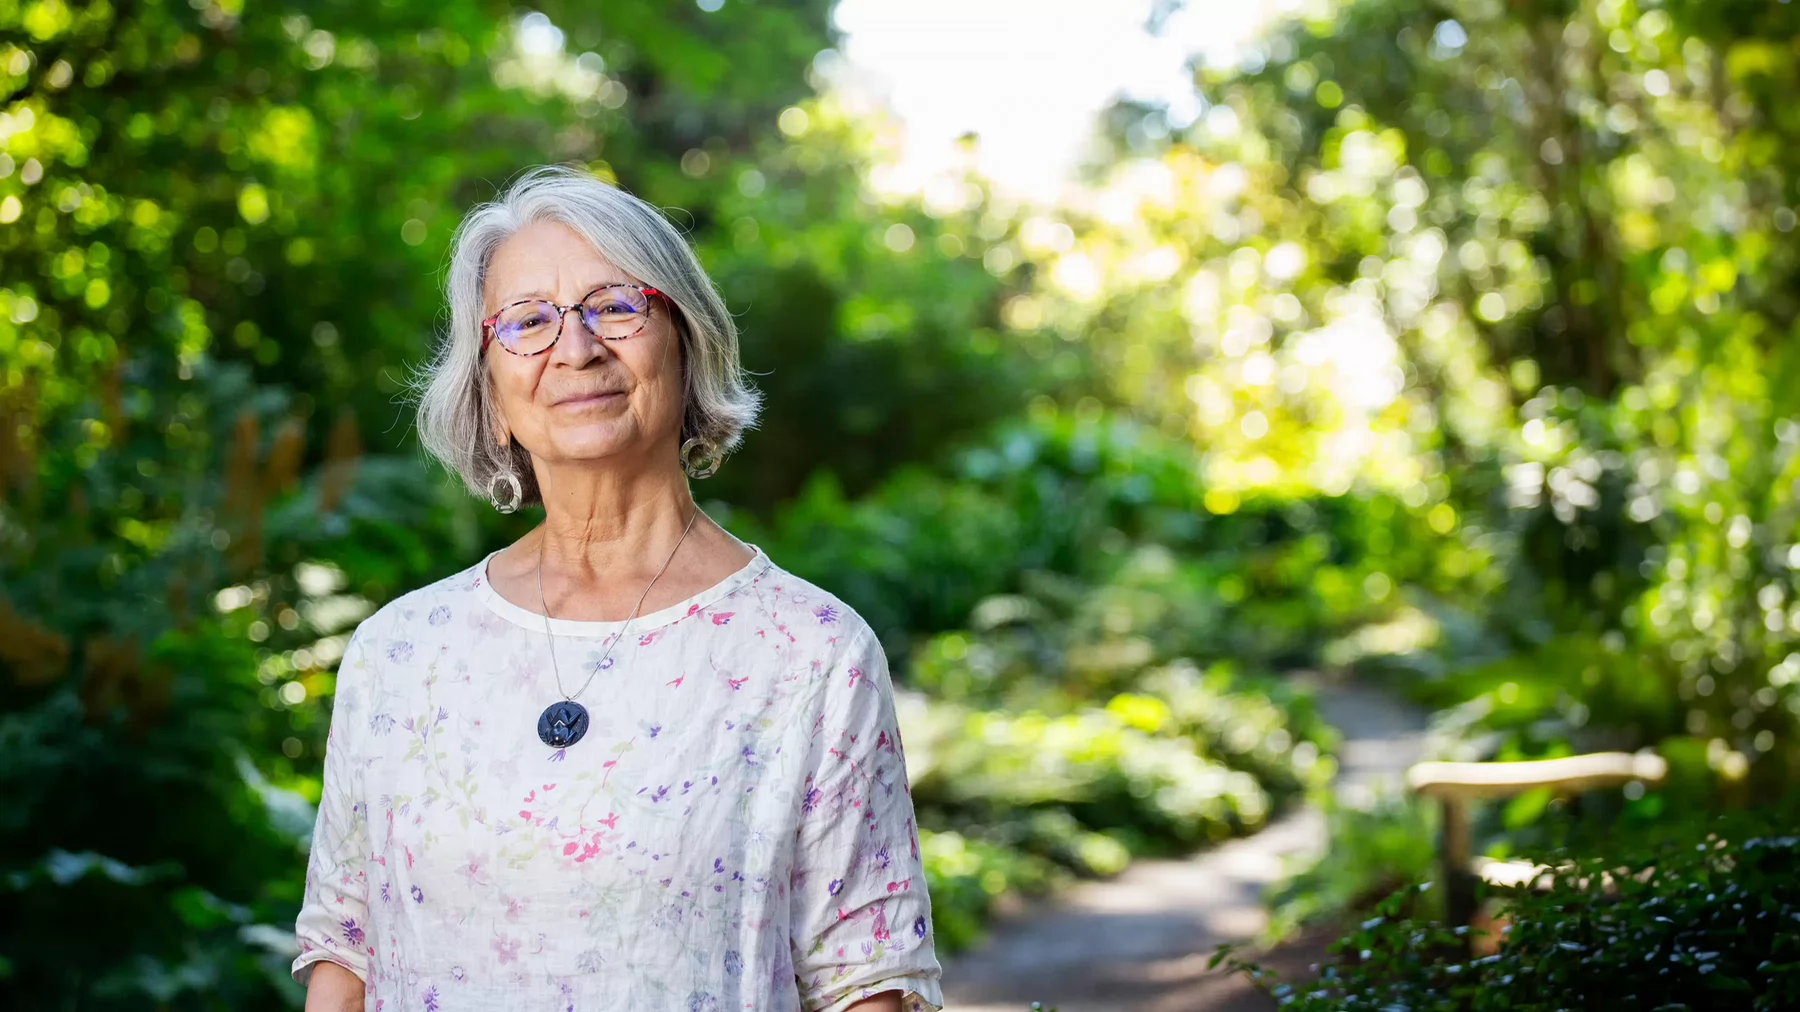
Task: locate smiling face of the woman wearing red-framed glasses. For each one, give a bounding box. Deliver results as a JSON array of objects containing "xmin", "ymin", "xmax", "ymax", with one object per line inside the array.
[{"xmin": 482, "ymin": 221, "xmax": 682, "ymax": 466}]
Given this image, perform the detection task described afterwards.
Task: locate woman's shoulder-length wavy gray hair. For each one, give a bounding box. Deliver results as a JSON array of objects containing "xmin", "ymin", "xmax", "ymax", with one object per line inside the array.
[{"xmin": 414, "ymin": 166, "xmax": 761, "ymax": 504}]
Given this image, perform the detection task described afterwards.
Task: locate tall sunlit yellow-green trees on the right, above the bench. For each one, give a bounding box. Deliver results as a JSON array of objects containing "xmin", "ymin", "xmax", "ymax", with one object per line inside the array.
[{"xmin": 1065, "ymin": 0, "xmax": 1800, "ymax": 794}]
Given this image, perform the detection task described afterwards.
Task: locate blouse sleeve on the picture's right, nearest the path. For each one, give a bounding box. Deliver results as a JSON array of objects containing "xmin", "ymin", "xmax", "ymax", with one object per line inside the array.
[{"xmin": 790, "ymin": 627, "xmax": 943, "ymax": 1012}]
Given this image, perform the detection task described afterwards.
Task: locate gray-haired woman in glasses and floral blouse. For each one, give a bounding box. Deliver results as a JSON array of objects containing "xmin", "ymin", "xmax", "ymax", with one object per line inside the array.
[{"xmin": 293, "ymin": 169, "xmax": 943, "ymax": 1012}]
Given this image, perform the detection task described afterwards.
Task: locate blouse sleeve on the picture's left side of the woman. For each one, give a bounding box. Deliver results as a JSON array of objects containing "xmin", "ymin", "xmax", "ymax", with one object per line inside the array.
[{"xmin": 292, "ymin": 618, "xmax": 374, "ymax": 985}]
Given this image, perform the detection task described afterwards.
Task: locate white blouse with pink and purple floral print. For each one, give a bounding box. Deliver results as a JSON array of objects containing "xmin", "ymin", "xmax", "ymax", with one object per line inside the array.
[{"xmin": 293, "ymin": 549, "xmax": 943, "ymax": 1012}]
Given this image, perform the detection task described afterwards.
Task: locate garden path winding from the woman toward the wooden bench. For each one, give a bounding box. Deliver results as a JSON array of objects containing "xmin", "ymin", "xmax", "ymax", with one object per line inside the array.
[{"xmin": 943, "ymin": 669, "xmax": 1426, "ymax": 1012}]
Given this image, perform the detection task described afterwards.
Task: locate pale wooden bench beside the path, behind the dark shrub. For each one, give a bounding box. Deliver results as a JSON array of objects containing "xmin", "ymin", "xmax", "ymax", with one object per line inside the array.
[{"xmin": 1406, "ymin": 753, "xmax": 1669, "ymax": 927}]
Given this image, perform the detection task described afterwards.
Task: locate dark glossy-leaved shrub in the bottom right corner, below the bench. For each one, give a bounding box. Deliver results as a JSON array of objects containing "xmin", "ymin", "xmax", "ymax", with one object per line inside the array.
[{"xmin": 1215, "ymin": 812, "xmax": 1800, "ymax": 1012}]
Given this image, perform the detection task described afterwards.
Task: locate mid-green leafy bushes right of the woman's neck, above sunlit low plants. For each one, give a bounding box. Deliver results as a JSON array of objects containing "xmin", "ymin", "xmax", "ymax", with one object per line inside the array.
[{"xmin": 745, "ymin": 407, "xmax": 1440, "ymax": 662}]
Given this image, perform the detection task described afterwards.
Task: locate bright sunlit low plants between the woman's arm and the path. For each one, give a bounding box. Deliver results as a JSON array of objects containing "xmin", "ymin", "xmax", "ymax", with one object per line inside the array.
[{"xmin": 902, "ymin": 663, "xmax": 1334, "ymax": 949}]
